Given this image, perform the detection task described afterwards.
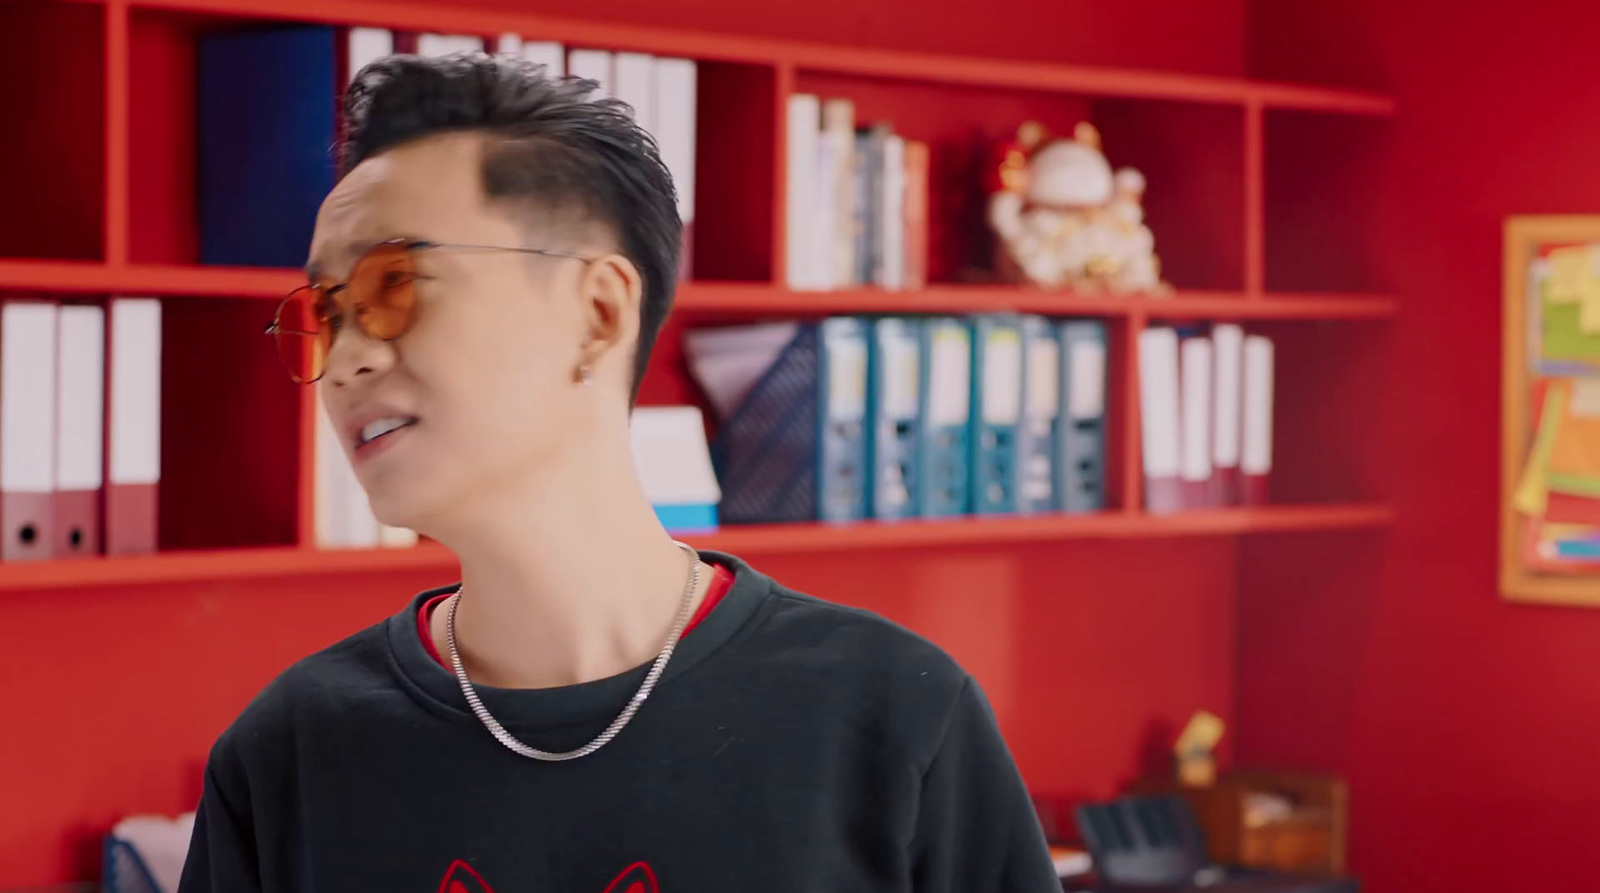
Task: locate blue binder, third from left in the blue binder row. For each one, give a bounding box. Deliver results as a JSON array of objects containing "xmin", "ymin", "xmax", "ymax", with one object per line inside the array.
[{"xmin": 917, "ymin": 317, "xmax": 973, "ymax": 517}]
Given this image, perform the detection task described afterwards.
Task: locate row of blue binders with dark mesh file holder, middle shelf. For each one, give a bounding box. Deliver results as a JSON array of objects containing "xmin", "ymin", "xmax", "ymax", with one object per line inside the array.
[{"xmin": 685, "ymin": 314, "xmax": 1106, "ymax": 523}]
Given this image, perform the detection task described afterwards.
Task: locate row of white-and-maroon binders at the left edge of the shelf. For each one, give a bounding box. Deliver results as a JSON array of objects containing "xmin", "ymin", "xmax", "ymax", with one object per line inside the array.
[{"xmin": 0, "ymin": 304, "xmax": 162, "ymax": 560}]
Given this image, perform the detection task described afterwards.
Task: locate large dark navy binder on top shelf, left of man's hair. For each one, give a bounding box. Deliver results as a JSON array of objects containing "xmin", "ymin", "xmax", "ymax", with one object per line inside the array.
[{"xmin": 195, "ymin": 26, "xmax": 339, "ymax": 267}]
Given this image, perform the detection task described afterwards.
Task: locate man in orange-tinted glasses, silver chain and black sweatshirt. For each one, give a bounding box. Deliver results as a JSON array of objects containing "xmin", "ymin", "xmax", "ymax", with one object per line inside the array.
[{"xmin": 181, "ymin": 54, "xmax": 1059, "ymax": 893}]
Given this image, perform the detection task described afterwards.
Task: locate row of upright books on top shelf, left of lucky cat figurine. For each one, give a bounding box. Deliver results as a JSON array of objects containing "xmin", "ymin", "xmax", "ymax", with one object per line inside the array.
[{"xmin": 786, "ymin": 93, "xmax": 928, "ymax": 290}]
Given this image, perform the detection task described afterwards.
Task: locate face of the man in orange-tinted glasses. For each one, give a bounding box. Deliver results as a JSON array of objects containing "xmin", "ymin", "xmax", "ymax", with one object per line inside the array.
[{"xmin": 310, "ymin": 134, "xmax": 587, "ymax": 533}]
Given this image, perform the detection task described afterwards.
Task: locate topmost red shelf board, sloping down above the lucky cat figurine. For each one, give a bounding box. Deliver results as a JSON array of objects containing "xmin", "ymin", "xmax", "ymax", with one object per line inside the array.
[{"xmin": 130, "ymin": 0, "xmax": 1394, "ymax": 115}]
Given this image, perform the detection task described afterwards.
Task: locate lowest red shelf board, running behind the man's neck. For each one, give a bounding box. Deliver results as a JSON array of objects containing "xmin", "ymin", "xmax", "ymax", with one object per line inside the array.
[{"xmin": 0, "ymin": 504, "xmax": 1394, "ymax": 594}]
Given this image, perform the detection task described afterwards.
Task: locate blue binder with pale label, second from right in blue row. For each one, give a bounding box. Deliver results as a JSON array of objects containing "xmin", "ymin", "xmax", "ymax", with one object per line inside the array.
[{"xmin": 1016, "ymin": 317, "xmax": 1061, "ymax": 514}]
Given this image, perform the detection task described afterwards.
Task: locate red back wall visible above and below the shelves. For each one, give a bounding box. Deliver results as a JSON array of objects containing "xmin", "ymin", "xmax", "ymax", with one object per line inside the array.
[{"xmin": 0, "ymin": 0, "xmax": 1245, "ymax": 888}]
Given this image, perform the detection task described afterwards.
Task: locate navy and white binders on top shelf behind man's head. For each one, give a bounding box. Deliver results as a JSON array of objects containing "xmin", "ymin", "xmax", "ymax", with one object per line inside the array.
[{"xmin": 197, "ymin": 26, "xmax": 698, "ymax": 277}]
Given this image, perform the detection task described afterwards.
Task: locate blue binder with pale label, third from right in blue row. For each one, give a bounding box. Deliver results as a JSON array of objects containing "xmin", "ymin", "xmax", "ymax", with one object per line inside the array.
[{"xmin": 970, "ymin": 314, "xmax": 1022, "ymax": 515}]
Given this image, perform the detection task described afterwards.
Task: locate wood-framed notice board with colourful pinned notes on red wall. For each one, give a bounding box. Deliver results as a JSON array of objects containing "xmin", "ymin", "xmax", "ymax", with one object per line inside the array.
[{"xmin": 1499, "ymin": 214, "xmax": 1600, "ymax": 607}]
